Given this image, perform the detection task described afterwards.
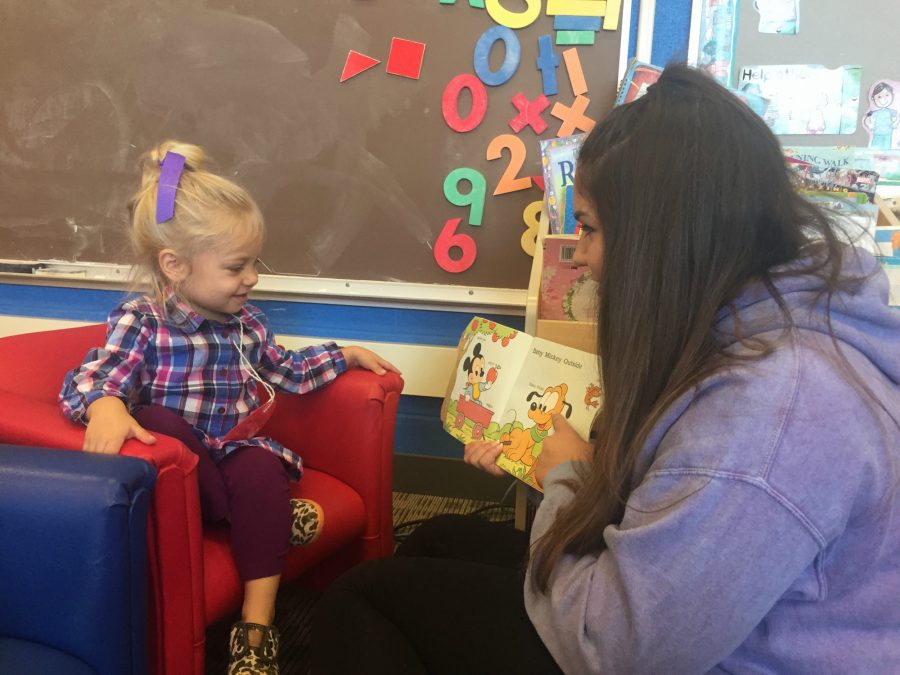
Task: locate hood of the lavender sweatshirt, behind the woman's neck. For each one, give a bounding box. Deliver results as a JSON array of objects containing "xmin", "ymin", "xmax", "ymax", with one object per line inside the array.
[{"xmin": 716, "ymin": 246, "xmax": 900, "ymax": 385}]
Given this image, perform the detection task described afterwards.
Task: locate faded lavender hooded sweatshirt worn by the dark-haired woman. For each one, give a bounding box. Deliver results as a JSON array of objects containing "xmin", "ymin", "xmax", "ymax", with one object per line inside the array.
[{"xmin": 525, "ymin": 252, "xmax": 900, "ymax": 675}]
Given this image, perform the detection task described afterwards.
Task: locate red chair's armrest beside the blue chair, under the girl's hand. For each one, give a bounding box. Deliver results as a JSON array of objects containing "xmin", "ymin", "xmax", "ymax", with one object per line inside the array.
[{"xmin": 0, "ymin": 391, "xmax": 206, "ymax": 672}]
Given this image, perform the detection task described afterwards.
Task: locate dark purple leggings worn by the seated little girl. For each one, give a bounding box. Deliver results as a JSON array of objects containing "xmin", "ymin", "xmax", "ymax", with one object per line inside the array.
[{"xmin": 134, "ymin": 405, "xmax": 291, "ymax": 581}]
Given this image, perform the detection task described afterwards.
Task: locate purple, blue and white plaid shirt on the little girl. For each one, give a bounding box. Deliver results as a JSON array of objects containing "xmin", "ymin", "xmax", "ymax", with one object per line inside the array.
[{"xmin": 59, "ymin": 294, "xmax": 347, "ymax": 477}]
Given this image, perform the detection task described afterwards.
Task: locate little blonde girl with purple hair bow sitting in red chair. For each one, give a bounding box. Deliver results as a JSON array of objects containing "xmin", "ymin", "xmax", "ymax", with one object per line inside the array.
[{"xmin": 60, "ymin": 141, "xmax": 396, "ymax": 675}]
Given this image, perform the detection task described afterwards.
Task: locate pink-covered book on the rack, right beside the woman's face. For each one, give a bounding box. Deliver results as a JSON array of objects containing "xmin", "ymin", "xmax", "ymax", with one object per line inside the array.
[{"xmin": 538, "ymin": 234, "xmax": 598, "ymax": 321}]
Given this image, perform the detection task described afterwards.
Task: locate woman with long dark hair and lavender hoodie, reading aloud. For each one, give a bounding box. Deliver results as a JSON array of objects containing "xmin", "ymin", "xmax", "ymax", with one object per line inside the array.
[{"xmin": 312, "ymin": 66, "xmax": 900, "ymax": 675}]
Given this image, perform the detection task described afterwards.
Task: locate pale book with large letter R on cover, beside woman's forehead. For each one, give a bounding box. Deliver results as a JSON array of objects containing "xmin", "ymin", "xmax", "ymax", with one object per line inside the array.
[{"xmin": 541, "ymin": 134, "xmax": 587, "ymax": 234}]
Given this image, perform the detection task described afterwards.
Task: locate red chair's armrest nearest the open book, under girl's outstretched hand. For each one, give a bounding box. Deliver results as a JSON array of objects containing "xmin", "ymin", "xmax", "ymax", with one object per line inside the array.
[{"xmin": 265, "ymin": 368, "xmax": 403, "ymax": 557}]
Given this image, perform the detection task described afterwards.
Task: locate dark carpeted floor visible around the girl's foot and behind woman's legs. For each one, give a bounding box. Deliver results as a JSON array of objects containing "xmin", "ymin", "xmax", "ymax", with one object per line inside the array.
[{"xmin": 206, "ymin": 492, "xmax": 513, "ymax": 675}]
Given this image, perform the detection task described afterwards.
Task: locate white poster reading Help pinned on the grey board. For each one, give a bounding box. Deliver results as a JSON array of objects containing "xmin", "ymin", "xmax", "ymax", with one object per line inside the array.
[{"xmin": 736, "ymin": 64, "xmax": 862, "ymax": 135}]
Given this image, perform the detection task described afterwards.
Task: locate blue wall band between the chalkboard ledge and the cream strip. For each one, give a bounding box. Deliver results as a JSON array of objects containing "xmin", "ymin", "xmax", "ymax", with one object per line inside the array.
[{"xmin": 0, "ymin": 284, "xmax": 525, "ymax": 347}]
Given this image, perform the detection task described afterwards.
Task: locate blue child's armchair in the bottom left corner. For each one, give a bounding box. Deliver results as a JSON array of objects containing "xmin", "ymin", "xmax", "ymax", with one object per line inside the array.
[{"xmin": 0, "ymin": 445, "xmax": 156, "ymax": 675}]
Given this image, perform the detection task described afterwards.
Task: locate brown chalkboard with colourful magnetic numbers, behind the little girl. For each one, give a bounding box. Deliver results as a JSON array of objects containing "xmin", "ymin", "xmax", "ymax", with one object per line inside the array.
[{"xmin": 0, "ymin": 0, "xmax": 630, "ymax": 288}]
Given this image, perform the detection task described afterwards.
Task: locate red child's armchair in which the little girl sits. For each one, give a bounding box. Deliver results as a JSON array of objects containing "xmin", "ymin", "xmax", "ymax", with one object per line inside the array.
[{"xmin": 0, "ymin": 325, "xmax": 403, "ymax": 675}]
